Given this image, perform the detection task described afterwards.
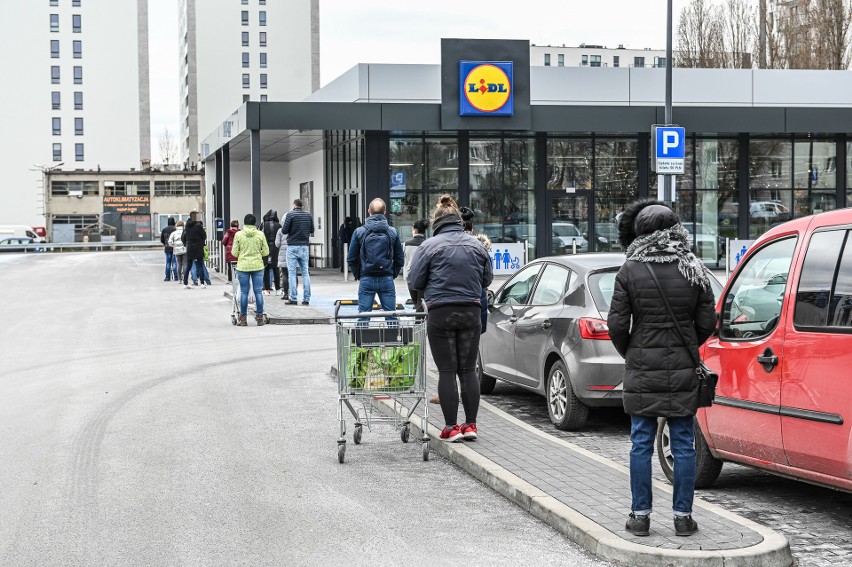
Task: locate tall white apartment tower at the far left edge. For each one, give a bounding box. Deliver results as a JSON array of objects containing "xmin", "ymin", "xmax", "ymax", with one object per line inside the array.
[{"xmin": 0, "ymin": 0, "xmax": 151, "ymax": 225}]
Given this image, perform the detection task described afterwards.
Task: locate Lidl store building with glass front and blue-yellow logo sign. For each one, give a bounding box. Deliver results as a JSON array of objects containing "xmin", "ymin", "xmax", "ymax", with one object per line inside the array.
[{"xmin": 202, "ymin": 39, "xmax": 852, "ymax": 267}]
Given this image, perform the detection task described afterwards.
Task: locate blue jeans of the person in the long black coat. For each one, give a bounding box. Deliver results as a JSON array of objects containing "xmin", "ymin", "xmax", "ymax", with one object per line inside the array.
[{"xmin": 630, "ymin": 415, "xmax": 695, "ymax": 516}]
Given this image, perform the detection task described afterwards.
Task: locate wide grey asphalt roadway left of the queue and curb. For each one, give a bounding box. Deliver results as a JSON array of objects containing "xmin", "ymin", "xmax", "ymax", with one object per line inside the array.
[{"xmin": 0, "ymin": 252, "xmax": 609, "ymax": 567}]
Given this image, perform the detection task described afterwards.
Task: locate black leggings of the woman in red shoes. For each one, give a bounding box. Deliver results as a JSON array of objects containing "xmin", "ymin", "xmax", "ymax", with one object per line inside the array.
[{"xmin": 426, "ymin": 302, "xmax": 482, "ymax": 427}]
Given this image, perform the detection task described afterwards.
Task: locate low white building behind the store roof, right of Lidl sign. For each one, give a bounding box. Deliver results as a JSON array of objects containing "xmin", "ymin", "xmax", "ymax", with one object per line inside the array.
[{"xmin": 530, "ymin": 43, "xmax": 666, "ymax": 68}]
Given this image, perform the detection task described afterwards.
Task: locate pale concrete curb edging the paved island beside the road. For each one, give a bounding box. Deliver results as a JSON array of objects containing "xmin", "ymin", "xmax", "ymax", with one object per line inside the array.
[{"xmin": 370, "ymin": 388, "xmax": 793, "ymax": 567}]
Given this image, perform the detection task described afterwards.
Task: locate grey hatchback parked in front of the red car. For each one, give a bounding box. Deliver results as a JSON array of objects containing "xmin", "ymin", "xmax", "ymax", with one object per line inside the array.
[{"xmin": 478, "ymin": 253, "xmax": 722, "ymax": 430}]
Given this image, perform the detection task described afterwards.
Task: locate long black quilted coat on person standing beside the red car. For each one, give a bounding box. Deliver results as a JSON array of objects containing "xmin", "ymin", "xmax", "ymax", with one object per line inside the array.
[{"xmin": 607, "ymin": 202, "xmax": 716, "ymax": 417}]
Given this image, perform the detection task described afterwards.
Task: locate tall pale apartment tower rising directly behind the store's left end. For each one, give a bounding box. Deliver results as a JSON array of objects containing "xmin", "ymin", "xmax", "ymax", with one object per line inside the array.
[{"xmin": 179, "ymin": 0, "xmax": 319, "ymax": 167}]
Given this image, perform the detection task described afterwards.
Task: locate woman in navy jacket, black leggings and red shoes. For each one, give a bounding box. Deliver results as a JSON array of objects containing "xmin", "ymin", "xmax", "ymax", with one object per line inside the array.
[{"xmin": 408, "ymin": 195, "xmax": 494, "ymax": 442}]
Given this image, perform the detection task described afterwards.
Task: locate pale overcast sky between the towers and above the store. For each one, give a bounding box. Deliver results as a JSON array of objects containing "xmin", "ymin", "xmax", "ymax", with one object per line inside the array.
[{"xmin": 149, "ymin": 0, "xmax": 688, "ymax": 160}]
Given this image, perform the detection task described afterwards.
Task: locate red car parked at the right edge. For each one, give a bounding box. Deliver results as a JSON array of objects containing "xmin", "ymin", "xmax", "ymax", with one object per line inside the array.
[{"xmin": 657, "ymin": 209, "xmax": 852, "ymax": 492}]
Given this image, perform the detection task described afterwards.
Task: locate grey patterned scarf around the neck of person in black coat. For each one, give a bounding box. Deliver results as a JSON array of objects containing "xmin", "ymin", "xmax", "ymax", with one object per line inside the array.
[{"xmin": 627, "ymin": 223, "xmax": 710, "ymax": 290}]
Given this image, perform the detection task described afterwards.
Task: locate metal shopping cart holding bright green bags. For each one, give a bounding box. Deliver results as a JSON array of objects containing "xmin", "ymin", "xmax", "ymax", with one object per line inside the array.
[{"xmin": 334, "ymin": 300, "xmax": 429, "ymax": 463}]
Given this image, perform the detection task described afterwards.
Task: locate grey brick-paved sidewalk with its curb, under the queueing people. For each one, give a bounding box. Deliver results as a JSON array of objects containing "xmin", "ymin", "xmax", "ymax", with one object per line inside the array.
[{"xmin": 225, "ymin": 269, "xmax": 793, "ymax": 567}]
